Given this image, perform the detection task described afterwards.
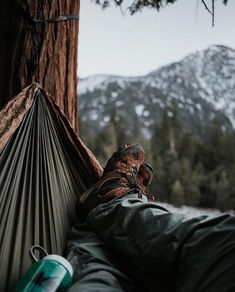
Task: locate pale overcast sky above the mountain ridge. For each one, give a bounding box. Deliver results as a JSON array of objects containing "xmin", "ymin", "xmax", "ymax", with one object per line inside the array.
[{"xmin": 78, "ymin": 0, "xmax": 235, "ymax": 77}]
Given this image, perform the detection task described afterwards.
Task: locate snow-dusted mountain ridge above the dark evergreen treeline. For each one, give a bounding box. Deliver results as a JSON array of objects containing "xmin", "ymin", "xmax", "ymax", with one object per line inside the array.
[{"xmin": 78, "ymin": 45, "xmax": 235, "ymax": 135}]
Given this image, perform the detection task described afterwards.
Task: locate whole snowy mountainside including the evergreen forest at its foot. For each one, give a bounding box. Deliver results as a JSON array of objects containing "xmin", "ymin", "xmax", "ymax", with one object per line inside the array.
[{"xmin": 79, "ymin": 45, "xmax": 235, "ymax": 211}]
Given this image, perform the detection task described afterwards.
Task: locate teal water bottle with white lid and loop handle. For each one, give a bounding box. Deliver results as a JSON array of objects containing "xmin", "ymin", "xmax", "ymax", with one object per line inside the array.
[{"xmin": 15, "ymin": 245, "xmax": 73, "ymax": 292}]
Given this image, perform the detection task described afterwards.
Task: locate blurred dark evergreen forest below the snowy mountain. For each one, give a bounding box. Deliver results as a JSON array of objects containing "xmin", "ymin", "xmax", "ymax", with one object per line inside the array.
[{"xmin": 81, "ymin": 106, "xmax": 235, "ymax": 211}]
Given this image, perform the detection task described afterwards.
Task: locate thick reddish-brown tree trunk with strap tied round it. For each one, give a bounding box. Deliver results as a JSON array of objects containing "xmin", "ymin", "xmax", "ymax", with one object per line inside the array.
[{"xmin": 0, "ymin": 0, "xmax": 80, "ymax": 131}]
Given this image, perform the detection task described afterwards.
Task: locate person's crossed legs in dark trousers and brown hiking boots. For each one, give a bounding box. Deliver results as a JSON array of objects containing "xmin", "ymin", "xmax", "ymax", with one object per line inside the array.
[{"xmin": 67, "ymin": 144, "xmax": 235, "ymax": 292}]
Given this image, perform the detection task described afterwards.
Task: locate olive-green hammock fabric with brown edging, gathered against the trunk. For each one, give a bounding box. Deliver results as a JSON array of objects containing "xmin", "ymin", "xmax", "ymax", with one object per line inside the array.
[{"xmin": 0, "ymin": 83, "xmax": 102, "ymax": 291}]
